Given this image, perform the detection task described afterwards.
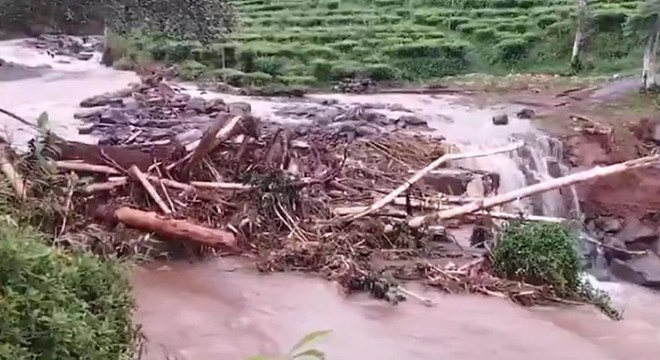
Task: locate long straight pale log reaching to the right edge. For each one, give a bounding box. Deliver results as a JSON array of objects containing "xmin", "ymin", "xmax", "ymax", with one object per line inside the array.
[{"xmin": 408, "ymin": 155, "xmax": 660, "ymax": 228}]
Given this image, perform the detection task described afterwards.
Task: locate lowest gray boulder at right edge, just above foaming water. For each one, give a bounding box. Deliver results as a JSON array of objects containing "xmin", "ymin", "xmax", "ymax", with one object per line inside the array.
[{"xmin": 610, "ymin": 253, "xmax": 660, "ymax": 287}]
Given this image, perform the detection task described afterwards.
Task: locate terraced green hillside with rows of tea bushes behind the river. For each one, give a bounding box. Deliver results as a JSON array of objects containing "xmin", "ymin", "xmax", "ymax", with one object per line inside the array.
[{"xmin": 113, "ymin": 0, "xmax": 642, "ymax": 85}]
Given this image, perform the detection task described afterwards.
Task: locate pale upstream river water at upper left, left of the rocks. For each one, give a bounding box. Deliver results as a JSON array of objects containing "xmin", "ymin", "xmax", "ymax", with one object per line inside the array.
[{"xmin": 0, "ymin": 40, "xmax": 139, "ymax": 147}]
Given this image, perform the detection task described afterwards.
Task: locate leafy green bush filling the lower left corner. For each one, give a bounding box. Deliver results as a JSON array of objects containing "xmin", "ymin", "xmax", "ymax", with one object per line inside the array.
[{"xmin": 0, "ymin": 218, "xmax": 140, "ymax": 360}]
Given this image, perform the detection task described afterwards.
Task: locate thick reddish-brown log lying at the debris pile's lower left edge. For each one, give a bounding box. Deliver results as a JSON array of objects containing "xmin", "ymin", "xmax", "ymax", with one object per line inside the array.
[{"xmin": 95, "ymin": 206, "xmax": 238, "ymax": 251}]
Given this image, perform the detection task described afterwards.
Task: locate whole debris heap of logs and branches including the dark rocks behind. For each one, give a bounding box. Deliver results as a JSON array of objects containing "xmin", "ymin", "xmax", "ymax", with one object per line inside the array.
[{"xmin": 0, "ymin": 77, "xmax": 657, "ymax": 310}]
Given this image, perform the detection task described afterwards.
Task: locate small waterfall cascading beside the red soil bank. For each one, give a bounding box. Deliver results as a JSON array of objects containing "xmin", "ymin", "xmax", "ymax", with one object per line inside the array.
[{"xmin": 457, "ymin": 133, "xmax": 580, "ymax": 218}]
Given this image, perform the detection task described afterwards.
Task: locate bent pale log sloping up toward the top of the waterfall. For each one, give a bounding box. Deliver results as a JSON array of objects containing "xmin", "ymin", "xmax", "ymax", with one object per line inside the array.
[{"xmin": 349, "ymin": 142, "xmax": 524, "ymax": 220}]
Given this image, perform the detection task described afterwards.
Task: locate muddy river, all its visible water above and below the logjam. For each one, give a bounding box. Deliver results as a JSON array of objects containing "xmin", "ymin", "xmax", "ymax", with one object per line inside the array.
[{"xmin": 0, "ymin": 41, "xmax": 660, "ymax": 360}]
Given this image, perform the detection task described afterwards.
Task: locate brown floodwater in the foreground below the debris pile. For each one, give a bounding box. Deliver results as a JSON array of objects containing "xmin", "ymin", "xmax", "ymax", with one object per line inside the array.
[{"xmin": 134, "ymin": 259, "xmax": 660, "ymax": 360}]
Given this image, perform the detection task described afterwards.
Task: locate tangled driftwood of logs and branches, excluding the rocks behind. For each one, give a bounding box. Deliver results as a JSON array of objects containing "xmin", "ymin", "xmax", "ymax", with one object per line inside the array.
[{"xmin": 0, "ymin": 75, "xmax": 659, "ymax": 303}]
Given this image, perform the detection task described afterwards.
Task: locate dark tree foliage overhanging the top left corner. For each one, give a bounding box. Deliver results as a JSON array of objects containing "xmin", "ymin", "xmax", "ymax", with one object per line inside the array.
[{"xmin": 0, "ymin": 0, "xmax": 236, "ymax": 43}]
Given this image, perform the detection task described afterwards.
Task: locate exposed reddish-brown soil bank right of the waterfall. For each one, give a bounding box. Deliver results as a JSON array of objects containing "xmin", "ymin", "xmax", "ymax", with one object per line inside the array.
[{"xmin": 462, "ymin": 78, "xmax": 660, "ymax": 221}]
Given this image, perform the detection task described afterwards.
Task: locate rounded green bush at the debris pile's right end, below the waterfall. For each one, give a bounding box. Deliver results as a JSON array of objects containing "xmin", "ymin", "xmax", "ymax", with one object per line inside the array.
[{"xmin": 493, "ymin": 222, "xmax": 621, "ymax": 319}]
